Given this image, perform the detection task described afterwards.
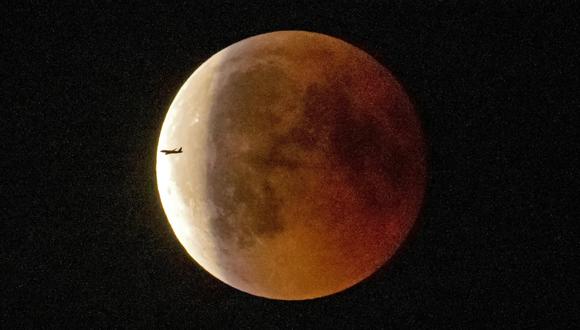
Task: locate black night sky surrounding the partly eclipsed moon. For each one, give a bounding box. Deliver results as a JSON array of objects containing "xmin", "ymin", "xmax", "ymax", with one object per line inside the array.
[{"xmin": 0, "ymin": 1, "xmax": 580, "ymax": 328}]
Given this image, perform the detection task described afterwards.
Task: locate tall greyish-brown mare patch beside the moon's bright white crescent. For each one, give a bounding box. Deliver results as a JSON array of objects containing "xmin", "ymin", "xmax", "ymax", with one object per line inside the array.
[{"xmin": 207, "ymin": 65, "xmax": 298, "ymax": 248}]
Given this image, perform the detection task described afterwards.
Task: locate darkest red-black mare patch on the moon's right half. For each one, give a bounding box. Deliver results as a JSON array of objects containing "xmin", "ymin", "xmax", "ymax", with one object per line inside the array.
[{"xmin": 292, "ymin": 77, "xmax": 406, "ymax": 220}]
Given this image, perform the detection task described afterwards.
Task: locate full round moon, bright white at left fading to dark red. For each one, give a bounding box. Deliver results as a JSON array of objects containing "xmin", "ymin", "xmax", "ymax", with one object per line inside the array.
[{"xmin": 156, "ymin": 31, "xmax": 426, "ymax": 300}]
